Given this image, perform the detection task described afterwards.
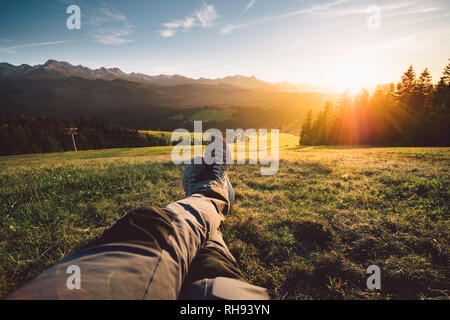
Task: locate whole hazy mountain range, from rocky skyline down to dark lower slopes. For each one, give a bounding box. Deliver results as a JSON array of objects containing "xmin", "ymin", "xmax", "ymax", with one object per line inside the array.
[{"xmin": 0, "ymin": 60, "xmax": 338, "ymax": 131}]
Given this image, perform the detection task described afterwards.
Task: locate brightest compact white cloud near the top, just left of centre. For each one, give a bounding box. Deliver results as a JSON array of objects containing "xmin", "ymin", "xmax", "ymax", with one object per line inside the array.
[{"xmin": 158, "ymin": 3, "xmax": 219, "ymax": 38}]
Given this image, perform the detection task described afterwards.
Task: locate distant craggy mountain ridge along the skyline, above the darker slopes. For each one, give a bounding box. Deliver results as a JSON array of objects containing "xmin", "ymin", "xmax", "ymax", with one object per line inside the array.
[{"xmin": 0, "ymin": 59, "xmax": 324, "ymax": 91}]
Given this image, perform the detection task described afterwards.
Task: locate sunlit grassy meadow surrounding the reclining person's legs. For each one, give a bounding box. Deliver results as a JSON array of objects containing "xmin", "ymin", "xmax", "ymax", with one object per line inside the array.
[{"xmin": 0, "ymin": 140, "xmax": 450, "ymax": 299}]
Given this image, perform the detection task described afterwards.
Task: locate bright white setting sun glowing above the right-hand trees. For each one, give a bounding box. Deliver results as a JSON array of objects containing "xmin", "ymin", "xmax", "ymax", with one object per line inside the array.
[{"xmin": 328, "ymin": 57, "xmax": 378, "ymax": 95}]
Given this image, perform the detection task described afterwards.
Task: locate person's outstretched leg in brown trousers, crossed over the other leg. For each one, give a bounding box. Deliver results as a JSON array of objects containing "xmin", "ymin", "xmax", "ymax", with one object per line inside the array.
[{"xmin": 8, "ymin": 175, "xmax": 231, "ymax": 299}]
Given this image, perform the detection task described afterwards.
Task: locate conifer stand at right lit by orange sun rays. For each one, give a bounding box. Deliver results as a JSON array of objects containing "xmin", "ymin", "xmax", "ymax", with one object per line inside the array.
[{"xmin": 300, "ymin": 63, "xmax": 450, "ymax": 146}]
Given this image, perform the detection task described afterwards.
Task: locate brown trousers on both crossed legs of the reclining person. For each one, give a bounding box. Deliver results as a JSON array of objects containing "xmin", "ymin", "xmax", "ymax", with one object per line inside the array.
[{"xmin": 7, "ymin": 186, "xmax": 268, "ymax": 300}]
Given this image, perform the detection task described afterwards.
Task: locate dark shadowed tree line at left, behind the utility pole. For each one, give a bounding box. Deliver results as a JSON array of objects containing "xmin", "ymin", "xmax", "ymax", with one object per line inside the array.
[{"xmin": 0, "ymin": 115, "xmax": 170, "ymax": 155}]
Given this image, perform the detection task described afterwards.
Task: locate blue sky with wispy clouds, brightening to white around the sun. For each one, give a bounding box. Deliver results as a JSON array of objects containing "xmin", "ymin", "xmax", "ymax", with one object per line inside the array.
[{"xmin": 0, "ymin": 0, "xmax": 450, "ymax": 90}]
